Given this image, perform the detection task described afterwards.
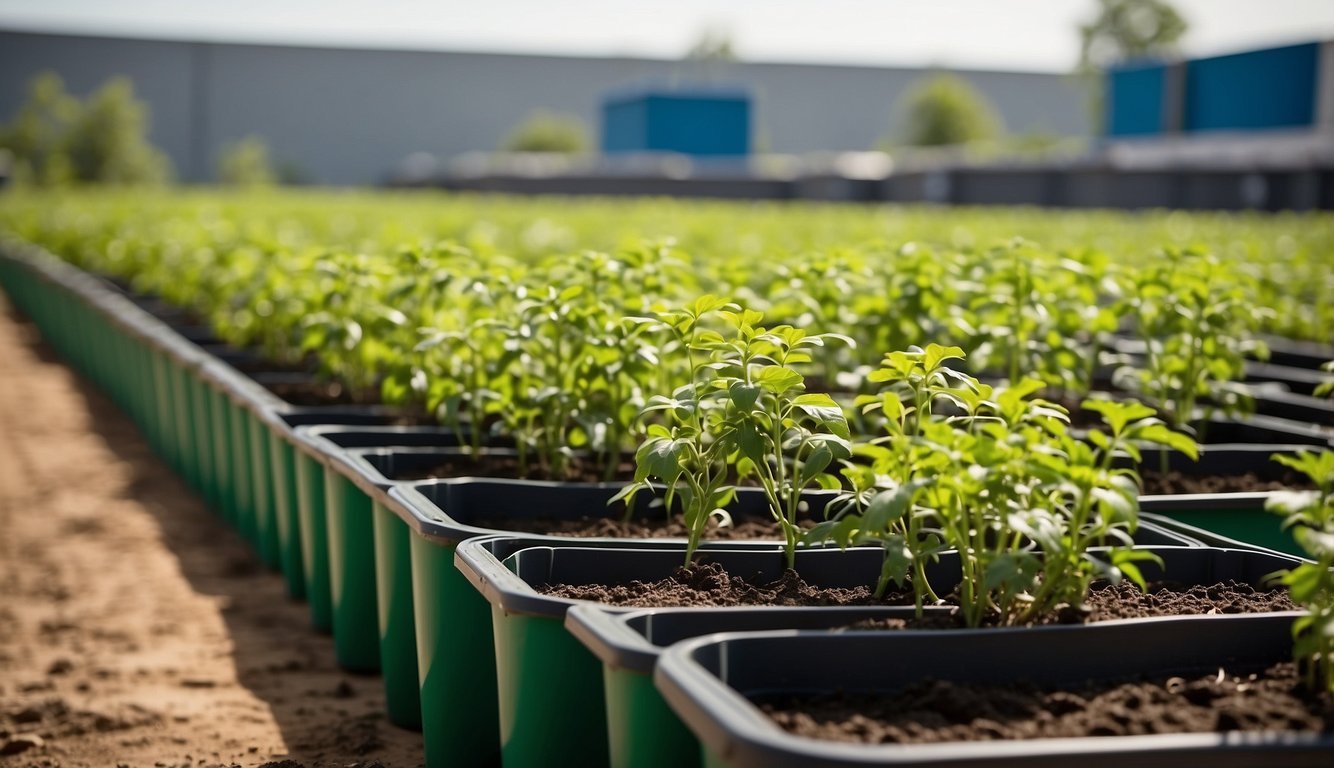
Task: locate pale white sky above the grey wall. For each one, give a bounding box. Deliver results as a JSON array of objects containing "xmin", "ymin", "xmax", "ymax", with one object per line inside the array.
[{"xmin": 0, "ymin": 0, "xmax": 1334, "ymax": 71}]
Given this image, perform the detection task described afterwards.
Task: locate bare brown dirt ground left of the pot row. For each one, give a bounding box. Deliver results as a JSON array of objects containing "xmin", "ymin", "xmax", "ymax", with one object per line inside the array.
[{"xmin": 0, "ymin": 296, "xmax": 422, "ymax": 768}]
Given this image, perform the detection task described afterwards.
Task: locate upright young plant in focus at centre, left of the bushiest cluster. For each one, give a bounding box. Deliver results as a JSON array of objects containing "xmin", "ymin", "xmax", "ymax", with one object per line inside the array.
[{"xmin": 618, "ymin": 296, "xmax": 851, "ymax": 568}]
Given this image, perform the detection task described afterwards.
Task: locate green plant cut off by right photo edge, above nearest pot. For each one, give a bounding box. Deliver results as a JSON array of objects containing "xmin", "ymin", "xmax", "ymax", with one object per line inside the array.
[{"xmin": 1265, "ymin": 448, "xmax": 1334, "ymax": 695}]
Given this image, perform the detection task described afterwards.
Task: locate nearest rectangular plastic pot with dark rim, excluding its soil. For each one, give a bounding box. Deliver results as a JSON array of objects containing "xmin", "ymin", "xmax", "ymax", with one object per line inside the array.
[{"xmin": 655, "ymin": 613, "xmax": 1334, "ymax": 768}]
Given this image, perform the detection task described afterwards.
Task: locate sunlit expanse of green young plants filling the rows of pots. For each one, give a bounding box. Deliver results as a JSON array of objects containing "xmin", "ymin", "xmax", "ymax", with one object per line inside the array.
[{"xmin": 0, "ymin": 189, "xmax": 1334, "ymax": 760}]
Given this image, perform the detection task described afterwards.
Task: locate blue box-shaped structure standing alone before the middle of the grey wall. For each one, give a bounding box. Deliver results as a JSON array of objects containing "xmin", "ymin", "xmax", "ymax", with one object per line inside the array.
[{"xmin": 602, "ymin": 88, "xmax": 751, "ymax": 157}]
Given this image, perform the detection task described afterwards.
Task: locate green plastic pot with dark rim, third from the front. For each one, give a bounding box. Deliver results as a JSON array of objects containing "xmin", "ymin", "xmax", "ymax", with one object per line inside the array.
[{"xmin": 455, "ymin": 536, "xmax": 1232, "ymax": 765}]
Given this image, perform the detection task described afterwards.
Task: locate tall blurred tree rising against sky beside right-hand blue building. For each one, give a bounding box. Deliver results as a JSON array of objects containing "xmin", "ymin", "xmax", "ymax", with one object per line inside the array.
[{"xmin": 1075, "ymin": 0, "xmax": 1189, "ymax": 127}]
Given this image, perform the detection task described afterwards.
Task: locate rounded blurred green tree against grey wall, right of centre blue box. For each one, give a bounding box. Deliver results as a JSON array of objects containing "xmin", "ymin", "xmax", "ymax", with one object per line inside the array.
[{"xmin": 899, "ymin": 73, "xmax": 1003, "ymax": 147}]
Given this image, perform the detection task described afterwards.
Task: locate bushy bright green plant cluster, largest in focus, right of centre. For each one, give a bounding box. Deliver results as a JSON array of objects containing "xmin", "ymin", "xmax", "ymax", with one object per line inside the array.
[{"xmin": 811, "ymin": 345, "xmax": 1195, "ymax": 627}]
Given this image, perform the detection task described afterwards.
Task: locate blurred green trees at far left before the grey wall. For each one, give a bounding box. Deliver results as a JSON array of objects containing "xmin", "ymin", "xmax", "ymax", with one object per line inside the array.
[{"xmin": 0, "ymin": 72, "xmax": 172, "ymax": 185}]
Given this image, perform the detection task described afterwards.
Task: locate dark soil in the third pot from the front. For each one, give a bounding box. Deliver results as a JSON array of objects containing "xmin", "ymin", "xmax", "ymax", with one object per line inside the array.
[{"xmin": 538, "ymin": 563, "xmax": 1297, "ymax": 618}]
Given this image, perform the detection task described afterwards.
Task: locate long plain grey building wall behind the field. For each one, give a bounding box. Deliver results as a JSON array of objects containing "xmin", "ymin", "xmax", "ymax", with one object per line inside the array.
[{"xmin": 0, "ymin": 31, "xmax": 1089, "ymax": 184}]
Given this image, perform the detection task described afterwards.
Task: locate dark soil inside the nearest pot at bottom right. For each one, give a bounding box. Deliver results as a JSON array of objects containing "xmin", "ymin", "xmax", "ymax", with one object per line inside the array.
[{"xmin": 755, "ymin": 661, "xmax": 1334, "ymax": 744}]
